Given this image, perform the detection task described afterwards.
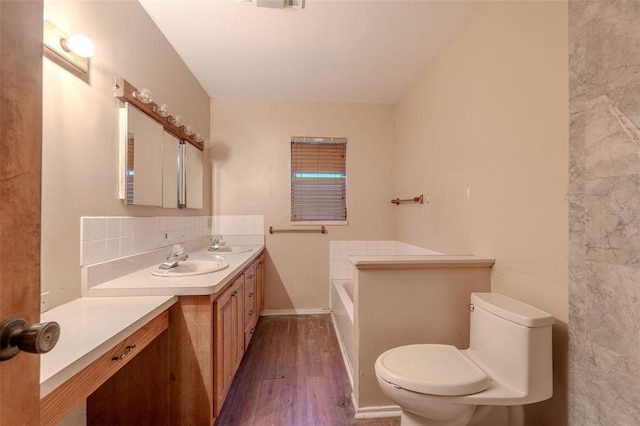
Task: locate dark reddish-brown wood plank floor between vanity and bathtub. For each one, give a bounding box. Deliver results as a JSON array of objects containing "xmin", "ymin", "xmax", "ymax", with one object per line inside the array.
[{"xmin": 216, "ymin": 315, "xmax": 400, "ymax": 426}]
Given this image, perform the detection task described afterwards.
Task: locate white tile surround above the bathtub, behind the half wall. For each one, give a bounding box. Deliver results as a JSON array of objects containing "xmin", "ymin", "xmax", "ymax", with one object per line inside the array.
[{"xmin": 329, "ymin": 241, "xmax": 440, "ymax": 280}]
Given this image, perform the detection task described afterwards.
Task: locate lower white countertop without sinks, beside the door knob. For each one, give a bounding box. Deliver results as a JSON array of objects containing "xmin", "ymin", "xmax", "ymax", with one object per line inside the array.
[{"xmin": 40, "ymin": 296, "xmax": 178, "ymax": 398}]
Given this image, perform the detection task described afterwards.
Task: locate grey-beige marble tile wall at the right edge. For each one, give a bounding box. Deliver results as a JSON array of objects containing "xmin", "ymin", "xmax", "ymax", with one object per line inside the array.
[{"xmin": 569, "ymin": 0, "xmax": 640, "ymax": 426}]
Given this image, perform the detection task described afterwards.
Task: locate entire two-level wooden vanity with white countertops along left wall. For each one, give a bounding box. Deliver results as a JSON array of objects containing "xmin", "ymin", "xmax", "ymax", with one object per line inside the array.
[{"xmin": 41, "ymin": 240, "xmax": 265, "ymax": 425}]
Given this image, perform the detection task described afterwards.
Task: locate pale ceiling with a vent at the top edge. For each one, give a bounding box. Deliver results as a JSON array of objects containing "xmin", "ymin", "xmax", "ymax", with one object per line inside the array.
[{"xmin": 139, "ymin": 0, "xmax": 481, "ymax": 103}]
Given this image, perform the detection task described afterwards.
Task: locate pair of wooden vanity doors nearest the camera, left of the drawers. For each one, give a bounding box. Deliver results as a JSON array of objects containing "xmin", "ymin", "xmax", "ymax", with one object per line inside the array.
[{"xmin": 213, "ymin": 274, "xmax": 245, "ymax": 415}]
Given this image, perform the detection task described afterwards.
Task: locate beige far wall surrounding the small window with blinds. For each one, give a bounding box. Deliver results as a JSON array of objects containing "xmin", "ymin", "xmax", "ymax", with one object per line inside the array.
[{"xmin": 211, "ymin": 99, "xmax": 394, "ymax": 311}]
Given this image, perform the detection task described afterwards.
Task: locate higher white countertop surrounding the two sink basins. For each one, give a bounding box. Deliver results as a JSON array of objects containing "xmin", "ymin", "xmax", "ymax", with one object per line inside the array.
[{"xmin": 87, "ymin": 244, "xmax": 264, "ymax": 297}]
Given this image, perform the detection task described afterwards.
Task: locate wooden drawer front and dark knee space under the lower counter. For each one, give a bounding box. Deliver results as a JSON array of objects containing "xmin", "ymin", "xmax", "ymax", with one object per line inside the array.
[{"xmin": 45, "ymin": 311, "xmax": 169, "ymax": 425}]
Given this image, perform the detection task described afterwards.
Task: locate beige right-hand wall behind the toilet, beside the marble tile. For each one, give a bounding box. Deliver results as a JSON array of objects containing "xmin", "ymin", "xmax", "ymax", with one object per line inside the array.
[{"xmin": 395, "ymin": 2, "xmax": 569, "ymax": 425}]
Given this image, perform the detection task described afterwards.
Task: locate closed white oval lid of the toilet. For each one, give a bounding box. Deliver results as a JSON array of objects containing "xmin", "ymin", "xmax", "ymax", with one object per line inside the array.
[{"xmin": 375, "ymin": 344, "xmax": 489, "ymax": 396}]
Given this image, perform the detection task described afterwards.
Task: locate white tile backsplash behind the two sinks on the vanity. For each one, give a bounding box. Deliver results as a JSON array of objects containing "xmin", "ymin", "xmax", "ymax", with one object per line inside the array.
[{"xmin": 80, "ymin": 215, "xmax": 264, "ymax": 265}]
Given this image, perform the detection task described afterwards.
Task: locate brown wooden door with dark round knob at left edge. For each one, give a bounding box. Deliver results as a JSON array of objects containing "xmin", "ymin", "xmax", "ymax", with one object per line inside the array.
[{"xmin": 0, "ymin": 0, "xmax": 43, "ymax": 426}]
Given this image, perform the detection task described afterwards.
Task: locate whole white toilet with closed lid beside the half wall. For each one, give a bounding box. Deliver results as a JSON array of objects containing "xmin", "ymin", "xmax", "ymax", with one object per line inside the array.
[{"xmin": 375, "ymin": 293, "xmax": 554, "ymax": 426}]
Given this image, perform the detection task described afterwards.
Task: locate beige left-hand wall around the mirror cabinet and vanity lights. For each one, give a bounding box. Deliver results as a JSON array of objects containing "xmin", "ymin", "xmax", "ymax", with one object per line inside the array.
[{"xmin": 42, "ymin": 0, "xmax": 211, "ymax": 307}]
